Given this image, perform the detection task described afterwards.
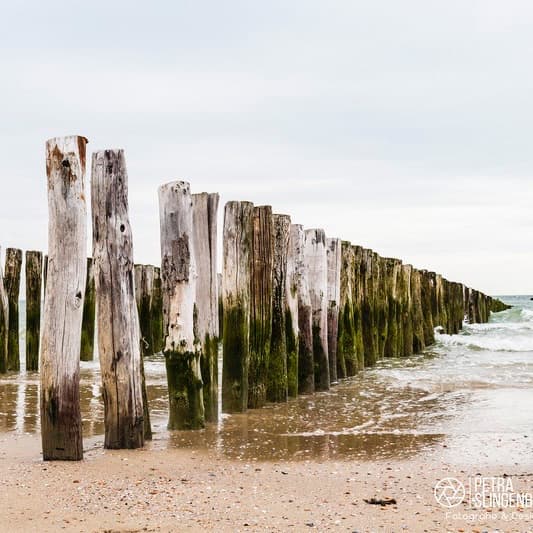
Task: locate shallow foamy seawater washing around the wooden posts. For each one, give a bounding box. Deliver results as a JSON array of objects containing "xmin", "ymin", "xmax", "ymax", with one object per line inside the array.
[{"xmin": 0, "ymin": 296, "xmax": 533, "ymax": 466}]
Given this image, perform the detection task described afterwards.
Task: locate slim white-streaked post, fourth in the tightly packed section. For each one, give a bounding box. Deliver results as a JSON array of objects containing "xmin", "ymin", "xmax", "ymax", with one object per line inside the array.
[{"xmin": 285, "ymin": 220, "xmax": 299, "ymax": 398}]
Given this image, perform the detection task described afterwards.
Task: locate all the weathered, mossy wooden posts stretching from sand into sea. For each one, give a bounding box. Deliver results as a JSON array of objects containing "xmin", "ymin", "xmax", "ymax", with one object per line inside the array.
[{"xmin": 0, "ymin": 136, "xmax": 505, "ymax": 460}]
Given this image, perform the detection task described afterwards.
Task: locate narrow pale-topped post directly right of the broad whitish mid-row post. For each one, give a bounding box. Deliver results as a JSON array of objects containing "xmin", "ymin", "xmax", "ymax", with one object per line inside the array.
[{"xmin": 326, "ymin": 238, "xmax": 342, "ymax": 383}]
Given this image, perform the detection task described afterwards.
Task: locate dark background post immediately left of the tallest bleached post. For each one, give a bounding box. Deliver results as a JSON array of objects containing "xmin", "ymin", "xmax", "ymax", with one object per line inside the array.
[{"xmin": 25, "ymin": 251, "xmax": 43, "ymax": 370}]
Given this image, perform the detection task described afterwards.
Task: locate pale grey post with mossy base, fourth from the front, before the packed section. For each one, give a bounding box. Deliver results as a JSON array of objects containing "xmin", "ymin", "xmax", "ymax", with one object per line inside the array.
[{"xmin": 192, "ymin": 192, "xmax": 219, "ymax": 422}]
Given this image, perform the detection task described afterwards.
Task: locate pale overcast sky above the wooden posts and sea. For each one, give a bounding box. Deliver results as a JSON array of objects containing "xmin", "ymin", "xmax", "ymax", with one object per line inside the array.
[{"xmin": 0, "ymin": 0, "xmax": 533, "ymax": 294}]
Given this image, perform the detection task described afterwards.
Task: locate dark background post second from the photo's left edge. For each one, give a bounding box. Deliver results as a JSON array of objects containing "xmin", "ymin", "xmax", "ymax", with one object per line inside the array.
[{"xmin": 4, "ymin": 248, "xmax": 22, "ymax": 371}]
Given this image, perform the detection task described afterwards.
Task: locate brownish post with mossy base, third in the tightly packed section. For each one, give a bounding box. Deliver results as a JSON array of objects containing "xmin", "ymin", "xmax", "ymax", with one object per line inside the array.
[{"xmin": 267, "ymin": 214, "xmax": 291, "ymax": 402}]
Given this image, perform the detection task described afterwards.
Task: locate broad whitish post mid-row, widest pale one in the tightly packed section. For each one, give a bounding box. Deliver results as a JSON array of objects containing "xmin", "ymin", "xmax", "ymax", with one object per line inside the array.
[{"xmin": 304, "ymin": 229, "xmax": 330, "ymax": 391}]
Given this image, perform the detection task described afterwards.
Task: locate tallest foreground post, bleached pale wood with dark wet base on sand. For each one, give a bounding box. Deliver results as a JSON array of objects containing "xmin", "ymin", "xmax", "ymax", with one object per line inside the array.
[{"xmin": 40, "ymin": 136, "xmax": 87, "ymax": 460}]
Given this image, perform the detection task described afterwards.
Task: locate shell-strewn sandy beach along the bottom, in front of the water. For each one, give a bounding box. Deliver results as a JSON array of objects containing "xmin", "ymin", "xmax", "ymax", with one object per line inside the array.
[{"xmin": 0, "ymin": 435, "xmax": 533, "ymax": 532}]
